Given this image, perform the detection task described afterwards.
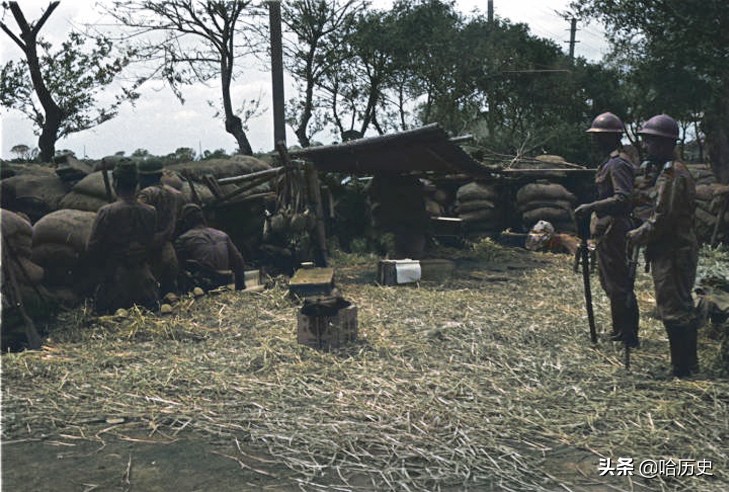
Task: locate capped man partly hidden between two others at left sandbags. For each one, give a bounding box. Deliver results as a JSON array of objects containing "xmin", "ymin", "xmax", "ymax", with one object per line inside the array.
[{"xmin": 139, "ymin": 159, "xmax": 184, "ymax": 294}]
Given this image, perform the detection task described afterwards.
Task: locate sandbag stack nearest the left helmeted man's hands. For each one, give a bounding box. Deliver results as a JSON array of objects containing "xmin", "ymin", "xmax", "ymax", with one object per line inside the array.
[{"xmin": 516, "ymin": 181, "xmax": 577, "ymax": 233}]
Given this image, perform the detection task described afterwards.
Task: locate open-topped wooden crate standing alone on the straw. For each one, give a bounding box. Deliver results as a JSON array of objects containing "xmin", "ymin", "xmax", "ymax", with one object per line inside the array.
[{"xmin": 296, "ymin": 304, "xmax": 357, "ymax": 350}]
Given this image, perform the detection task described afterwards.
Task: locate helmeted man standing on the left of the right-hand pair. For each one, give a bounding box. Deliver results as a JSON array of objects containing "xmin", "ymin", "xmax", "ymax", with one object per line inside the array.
[{"xmin": 575, "ymin": 112, "xmax": 639, "ymax": 347}]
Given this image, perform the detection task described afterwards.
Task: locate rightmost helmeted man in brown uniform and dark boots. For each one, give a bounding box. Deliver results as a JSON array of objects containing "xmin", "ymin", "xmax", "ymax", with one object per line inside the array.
[{"xmin": 628, "ymin": 114, "xmax": 699, "ymax": 377}]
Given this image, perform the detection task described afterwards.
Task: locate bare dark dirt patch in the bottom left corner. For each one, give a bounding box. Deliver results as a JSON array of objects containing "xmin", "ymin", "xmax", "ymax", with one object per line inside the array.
[{"xmin": 2, "ymin": 424, "xmax": 299, "ymax": 492}]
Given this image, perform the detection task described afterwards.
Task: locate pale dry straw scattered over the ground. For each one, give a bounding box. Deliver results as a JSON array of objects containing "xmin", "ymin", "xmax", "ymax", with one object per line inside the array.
[{"xmin": 2, "ymin": 244, "xmax": 729, "ymax": 491}]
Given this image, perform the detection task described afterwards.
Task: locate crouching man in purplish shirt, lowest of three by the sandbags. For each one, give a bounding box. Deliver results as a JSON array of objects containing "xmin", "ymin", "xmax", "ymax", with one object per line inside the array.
[{"xmin": 175, "ymin": 203, "xmax": 246, "ymax": 290}]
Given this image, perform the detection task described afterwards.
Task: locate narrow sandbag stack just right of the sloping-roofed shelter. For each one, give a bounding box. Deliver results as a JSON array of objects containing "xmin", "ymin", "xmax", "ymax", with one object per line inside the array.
[{"xmin": 455, "ymin": 181, "xmax": 505, "ymax": 240}]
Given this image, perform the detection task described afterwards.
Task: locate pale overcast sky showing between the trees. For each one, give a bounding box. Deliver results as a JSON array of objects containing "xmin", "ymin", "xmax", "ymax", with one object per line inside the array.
[{"xmin": 0, "ymin": 0, "xmax": 607, "ymax": 159}]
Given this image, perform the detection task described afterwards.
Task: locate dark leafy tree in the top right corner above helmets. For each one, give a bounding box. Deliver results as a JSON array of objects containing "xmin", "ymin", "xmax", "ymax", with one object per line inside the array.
[{"xmin": 572, "ymin": 0, "xmax": 729, "ymax": 183}]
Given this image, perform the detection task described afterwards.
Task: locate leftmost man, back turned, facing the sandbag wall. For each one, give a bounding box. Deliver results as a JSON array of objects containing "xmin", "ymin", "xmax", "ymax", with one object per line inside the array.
[{"xmin": 87, "ymin": 159, "xmax": 159, "ymax": 314}]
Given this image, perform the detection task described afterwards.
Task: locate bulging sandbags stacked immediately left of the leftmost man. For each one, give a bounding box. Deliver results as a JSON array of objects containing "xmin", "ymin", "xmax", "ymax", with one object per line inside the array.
[{"xmin": 32, "ymin": 209, "xmax": 96, "ymax": 305}]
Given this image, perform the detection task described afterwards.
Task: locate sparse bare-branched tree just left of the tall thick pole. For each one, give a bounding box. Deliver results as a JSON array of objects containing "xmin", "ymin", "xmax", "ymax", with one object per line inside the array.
[{"xmin": 107, "ymin": 0, "xmax": 264, "ymax": 155}]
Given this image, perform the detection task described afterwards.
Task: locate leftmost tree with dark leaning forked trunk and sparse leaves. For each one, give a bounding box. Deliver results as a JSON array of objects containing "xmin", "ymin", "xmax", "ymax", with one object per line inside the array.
[{"xmin": 0, "ymin": 1, "xmax": 144, "ymax": 162}]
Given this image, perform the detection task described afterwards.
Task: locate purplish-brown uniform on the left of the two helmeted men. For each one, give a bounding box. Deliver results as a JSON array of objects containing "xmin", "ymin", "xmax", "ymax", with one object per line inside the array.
[{"xmin": 591, "ymin": 150, "xmax": 638, "ymax": 346}]
